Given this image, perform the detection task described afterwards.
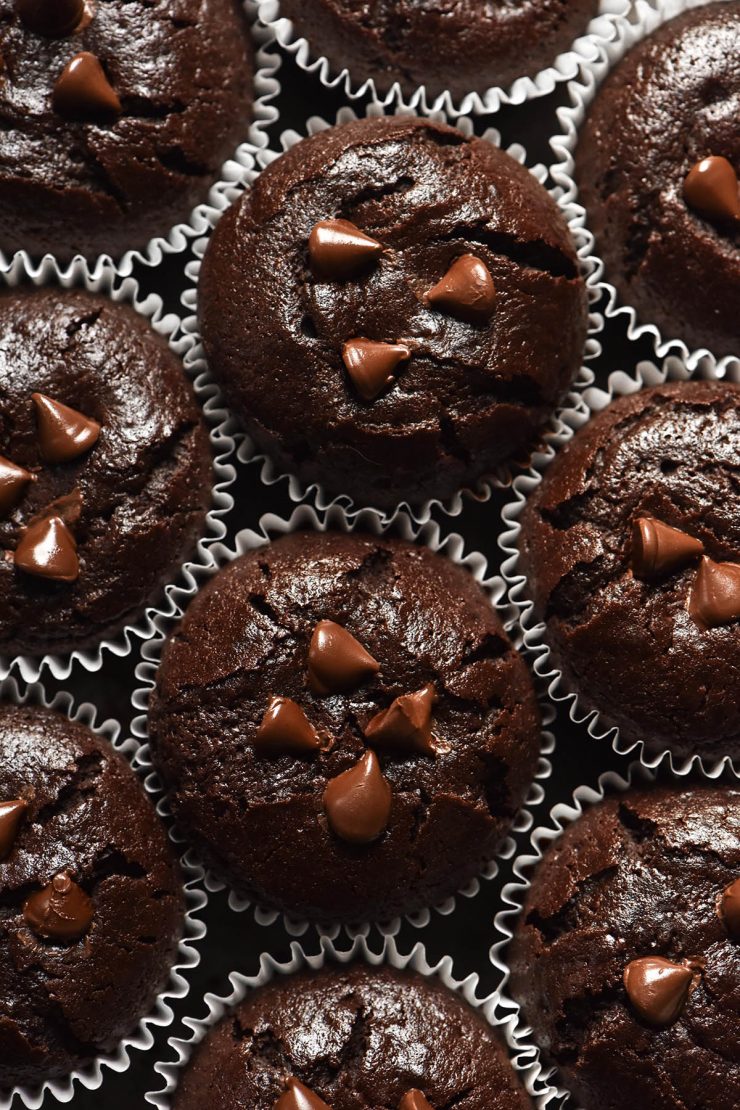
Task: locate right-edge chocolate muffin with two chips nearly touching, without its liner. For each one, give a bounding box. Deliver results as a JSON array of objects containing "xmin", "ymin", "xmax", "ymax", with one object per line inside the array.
[{"xmin": 519, "ymin": 381, "xmax": 740, "ymax": 759}]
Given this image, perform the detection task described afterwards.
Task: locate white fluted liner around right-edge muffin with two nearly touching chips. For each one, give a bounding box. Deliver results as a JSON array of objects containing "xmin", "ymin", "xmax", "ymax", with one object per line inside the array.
[{"xmin": 498, "ymin": 356, "xmax": 740, "ymax": 778}]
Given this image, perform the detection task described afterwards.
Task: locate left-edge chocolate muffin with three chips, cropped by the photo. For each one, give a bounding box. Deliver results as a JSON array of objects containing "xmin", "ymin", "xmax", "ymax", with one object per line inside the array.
[{"xmin": 0, "ymin": 289, "xmax": 212, "ymax": 656}]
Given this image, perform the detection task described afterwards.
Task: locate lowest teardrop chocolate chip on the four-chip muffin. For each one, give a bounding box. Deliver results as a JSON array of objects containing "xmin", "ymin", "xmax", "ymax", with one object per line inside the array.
[{"xmin": 324, "ymin": 751, "xmax": 392, "ymax": 844}]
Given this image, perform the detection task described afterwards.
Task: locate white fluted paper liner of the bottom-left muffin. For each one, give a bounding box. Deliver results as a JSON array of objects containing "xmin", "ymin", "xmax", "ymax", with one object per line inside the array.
[{"xmin": 0, "ymin": 677, "xmax": 207, "ymax": 1110}]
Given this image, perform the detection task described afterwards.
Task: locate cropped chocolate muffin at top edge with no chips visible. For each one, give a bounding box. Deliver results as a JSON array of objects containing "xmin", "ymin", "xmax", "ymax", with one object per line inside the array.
[{"xmin": 280, "ymin": 0, "xmax": 599, "ymax": 100}]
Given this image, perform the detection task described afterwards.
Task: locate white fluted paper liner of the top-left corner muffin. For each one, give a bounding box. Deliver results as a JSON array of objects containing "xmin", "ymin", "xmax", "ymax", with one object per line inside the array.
[{"xmin": 0, "ymin": 8, "xmax": 281, "ymax": 278}]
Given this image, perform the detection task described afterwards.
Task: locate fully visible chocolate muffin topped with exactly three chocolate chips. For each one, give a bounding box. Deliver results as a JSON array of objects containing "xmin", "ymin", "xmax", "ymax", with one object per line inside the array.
[{"xmin": 200, "ymin": 118, "xmax": 586, "ymax": 508}]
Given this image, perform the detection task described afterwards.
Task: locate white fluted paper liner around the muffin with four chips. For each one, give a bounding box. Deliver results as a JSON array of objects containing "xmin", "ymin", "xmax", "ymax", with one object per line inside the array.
[{"xmin": 131, "ymin": 505, "xmax": 555, "ymax": 938}]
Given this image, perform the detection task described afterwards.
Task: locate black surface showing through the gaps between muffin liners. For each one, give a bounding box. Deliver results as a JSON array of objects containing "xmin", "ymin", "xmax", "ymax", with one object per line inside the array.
[{"xmin": 37, "ymin": 39, "xmax": 653, "ymax": 1110}]
